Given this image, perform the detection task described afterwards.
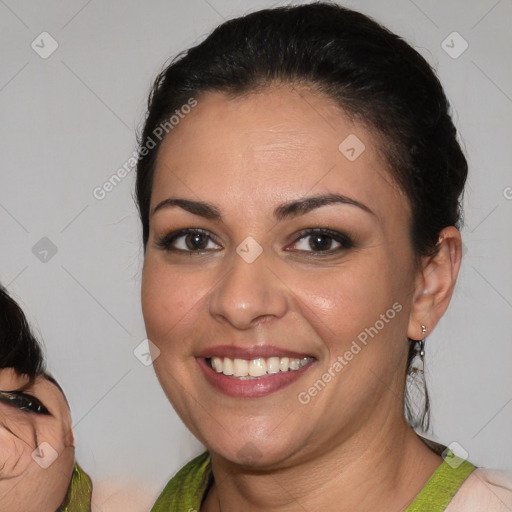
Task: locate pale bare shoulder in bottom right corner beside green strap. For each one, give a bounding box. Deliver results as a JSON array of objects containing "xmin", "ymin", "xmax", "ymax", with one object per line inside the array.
[{"xmin": 446, "ymin": 468, "xmax": 512, "ymax": 512}]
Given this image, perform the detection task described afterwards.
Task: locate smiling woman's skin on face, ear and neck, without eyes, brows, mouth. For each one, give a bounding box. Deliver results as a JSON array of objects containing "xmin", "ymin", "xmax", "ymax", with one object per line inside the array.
[{"xmin": 142, "ymin": 85, "xmax": 461, "ymax": 512}]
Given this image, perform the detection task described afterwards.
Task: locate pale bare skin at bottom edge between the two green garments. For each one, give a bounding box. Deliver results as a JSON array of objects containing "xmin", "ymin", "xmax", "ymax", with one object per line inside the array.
[{"xmin": 91, "ymin": 478, "xmax": 159, "ymax": 512}]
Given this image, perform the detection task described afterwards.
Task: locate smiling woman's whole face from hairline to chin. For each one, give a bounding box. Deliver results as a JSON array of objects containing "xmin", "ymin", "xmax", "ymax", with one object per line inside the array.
[{"xmin": 142, "ymin": 87, "xmax": 422, "ymax": 467}]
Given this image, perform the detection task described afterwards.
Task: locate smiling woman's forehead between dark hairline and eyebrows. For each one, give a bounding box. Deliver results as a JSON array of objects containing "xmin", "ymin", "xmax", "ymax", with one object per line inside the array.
[{"xmin": 151, "ymin": 85, "xmax": 407, "ymax": 222}]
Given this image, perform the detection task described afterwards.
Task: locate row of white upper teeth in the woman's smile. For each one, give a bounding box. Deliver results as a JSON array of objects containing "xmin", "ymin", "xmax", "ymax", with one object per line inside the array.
[{"xmin": 209, "ymin": 356, "xmax": 313, "ymax": 379}]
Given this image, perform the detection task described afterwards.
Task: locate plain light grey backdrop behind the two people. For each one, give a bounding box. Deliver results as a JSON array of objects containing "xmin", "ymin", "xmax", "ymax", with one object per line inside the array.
[{"xmin": 0, "ymin": 0, "xmax": 512, "ymax": 494}]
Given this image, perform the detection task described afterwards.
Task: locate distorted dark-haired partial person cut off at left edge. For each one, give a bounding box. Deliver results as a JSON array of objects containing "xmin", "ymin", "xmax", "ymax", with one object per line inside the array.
[{"xmin": 0, "ymin": 287, "xmax": 92, "ymax": 512}]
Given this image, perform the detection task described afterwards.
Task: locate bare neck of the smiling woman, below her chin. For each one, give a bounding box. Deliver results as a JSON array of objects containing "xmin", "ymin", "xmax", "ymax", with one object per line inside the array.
[{"xmin": 201, "ymin": 414, "xmax": 442, "ymax": 512}]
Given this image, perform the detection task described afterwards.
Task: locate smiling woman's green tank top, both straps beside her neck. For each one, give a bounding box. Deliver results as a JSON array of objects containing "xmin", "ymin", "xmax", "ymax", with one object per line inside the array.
[{"xmin": 151, "ymin": 451, "xmax": 475, "ymax": 512}]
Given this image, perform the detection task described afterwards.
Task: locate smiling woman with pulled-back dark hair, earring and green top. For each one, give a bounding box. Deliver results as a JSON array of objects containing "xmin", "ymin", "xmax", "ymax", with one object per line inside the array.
[{"xmin": 133, "ymin": 3, "xmax": 512, "ymax": 512}]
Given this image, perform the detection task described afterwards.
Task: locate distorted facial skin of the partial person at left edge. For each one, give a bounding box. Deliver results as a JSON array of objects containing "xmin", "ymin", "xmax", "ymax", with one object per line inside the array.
[{"xmin": 0, "ymin": 368, "xmax": 75, "ymax": 512}]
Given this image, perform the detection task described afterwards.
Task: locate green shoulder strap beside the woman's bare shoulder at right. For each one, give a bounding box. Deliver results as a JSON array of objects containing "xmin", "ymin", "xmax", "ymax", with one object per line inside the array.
[{"xmin": 404, "ymin": 450, "xmax": 475, "ymax": 512}]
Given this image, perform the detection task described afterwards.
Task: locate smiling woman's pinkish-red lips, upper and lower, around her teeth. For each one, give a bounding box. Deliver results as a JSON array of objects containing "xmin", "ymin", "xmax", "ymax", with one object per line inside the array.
[{"xmin": 196, "ymin": 345, "xmax": 316, "ymax": 398}]
